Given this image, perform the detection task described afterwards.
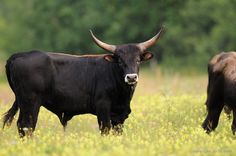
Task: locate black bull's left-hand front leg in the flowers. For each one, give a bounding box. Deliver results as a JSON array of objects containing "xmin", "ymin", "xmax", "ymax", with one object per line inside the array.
[{"xmin": 97, "ymin": 106, "xmax": 111, "ymax": 135}]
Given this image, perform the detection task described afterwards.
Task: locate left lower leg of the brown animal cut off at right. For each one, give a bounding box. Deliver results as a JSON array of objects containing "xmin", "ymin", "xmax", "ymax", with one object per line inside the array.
[{"xmin": 202, "ymin": 102, "xmax": 224, "ymax": 133}]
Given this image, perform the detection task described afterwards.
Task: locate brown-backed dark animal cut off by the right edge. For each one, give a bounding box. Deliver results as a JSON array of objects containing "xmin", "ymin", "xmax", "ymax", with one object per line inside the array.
[{"xmin": 202, "ymin": 52, "xmax": 236, "ymax": 134}]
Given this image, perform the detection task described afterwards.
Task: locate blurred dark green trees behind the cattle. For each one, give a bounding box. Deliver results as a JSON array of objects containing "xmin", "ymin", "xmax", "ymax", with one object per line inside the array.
[{"xmin": 0, "ymin": 0, "xmax": 236, "ymax": 73}]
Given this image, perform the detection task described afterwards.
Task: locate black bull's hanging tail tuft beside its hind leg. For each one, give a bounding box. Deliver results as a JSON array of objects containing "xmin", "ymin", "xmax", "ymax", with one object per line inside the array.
[{"xmin": 2, "ymin": 101, "xmax": 18, "ymax": 129}]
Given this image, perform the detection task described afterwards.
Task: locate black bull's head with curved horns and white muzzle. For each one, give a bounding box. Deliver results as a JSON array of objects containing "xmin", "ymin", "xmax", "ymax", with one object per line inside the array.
[{"xmin": 90, "ymin": 27, "xmax": 164, "ymax": 85}]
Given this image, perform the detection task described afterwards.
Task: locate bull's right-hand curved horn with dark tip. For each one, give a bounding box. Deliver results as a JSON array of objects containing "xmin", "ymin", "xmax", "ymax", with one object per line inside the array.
[{"xmin": 138, "ymin": 26, "xmax": 164, "ymax": 51}]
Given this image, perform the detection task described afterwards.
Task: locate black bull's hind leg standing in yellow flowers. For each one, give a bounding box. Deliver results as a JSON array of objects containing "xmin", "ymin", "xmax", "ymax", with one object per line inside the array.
[{"xmin": 17, "ymin": 96, "xmax": 40, "ymax": 137}]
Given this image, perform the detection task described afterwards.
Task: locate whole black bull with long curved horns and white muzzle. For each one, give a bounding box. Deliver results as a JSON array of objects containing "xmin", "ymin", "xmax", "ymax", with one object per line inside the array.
[{"xmin": 3, "ymin": 29, "xmax": 163, "ymax": 137}]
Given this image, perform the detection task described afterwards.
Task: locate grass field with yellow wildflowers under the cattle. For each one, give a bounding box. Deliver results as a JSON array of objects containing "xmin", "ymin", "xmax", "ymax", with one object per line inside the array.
[{"xmin": 0, "ymin": 70, "xmax": 236, "ymax": 156}]
